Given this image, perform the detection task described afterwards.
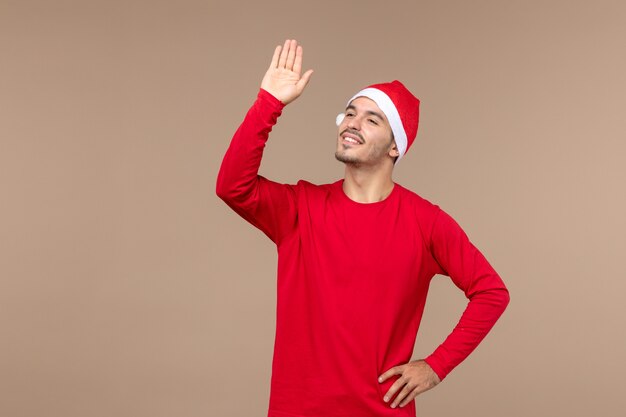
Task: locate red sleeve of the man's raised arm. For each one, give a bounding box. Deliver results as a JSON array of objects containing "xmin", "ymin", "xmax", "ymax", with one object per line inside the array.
[{"xmin": 216, "ymin": 89, "xmax": 296, "ymax": 244}]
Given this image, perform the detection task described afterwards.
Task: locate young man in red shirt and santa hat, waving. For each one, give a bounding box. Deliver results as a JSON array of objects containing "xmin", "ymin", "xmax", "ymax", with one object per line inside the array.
[{"xmin": 217, "ymin": 40, "xmax": 509, "ymax": 417}]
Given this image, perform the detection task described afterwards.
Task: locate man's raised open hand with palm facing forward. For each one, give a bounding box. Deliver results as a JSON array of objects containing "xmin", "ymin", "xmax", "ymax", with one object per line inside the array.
[{"xmin": 261, "ymin": 39, "xmax": 313, "ymax": 104}]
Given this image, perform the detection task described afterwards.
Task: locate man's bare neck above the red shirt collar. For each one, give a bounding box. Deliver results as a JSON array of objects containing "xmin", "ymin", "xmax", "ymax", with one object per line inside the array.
[{"xmin": 343, "ymin": 164, "xmax": 394, "ymax": 203}]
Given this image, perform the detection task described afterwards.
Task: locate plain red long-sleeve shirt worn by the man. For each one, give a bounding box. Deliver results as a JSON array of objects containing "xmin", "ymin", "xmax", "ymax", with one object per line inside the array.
[{"xmin": 217, "ymin": 89, "xmax": 509, "ymax": 417}]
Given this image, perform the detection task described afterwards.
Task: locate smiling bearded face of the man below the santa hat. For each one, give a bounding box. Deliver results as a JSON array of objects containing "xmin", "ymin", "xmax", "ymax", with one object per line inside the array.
[{"xmin": 335, "ymin": 97, "xmax": 398, "ymax": 166}]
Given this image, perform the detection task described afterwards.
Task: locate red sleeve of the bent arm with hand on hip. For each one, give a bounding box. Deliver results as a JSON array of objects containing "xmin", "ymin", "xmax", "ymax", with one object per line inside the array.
[{"xmin": 425, "ymin": 209, "xmax": 510, "ymax": 380}]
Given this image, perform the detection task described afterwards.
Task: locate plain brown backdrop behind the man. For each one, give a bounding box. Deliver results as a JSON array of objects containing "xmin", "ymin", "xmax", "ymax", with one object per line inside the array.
[{"xmin": 0, "ymin": 0, "xmax": 626, "ymax": 417}]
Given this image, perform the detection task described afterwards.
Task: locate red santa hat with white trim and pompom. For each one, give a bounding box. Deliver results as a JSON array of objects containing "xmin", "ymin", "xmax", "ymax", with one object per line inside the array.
[{"xmin": 336, "ymin": 80, "xmax": 420, "ymax": 163}]
